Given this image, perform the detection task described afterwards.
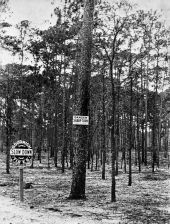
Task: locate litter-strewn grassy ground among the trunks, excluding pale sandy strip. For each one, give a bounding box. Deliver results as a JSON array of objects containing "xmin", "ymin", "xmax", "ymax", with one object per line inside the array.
[{"xmin": 0, "ymin": 154, "xmax": 170, "ymax": 224}]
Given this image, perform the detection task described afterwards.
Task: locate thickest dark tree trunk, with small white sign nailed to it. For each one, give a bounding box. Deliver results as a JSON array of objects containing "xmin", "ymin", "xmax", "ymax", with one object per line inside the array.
[{"xmin": 69, "ymin": 0, "xmax": 94, "ymax": 199}]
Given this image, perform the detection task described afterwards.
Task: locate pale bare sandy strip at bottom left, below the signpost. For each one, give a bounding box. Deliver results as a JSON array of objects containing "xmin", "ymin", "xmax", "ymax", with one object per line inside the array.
[{"xmin": 0, "ymin": 196, "xmax": 105, "ymax": 224}]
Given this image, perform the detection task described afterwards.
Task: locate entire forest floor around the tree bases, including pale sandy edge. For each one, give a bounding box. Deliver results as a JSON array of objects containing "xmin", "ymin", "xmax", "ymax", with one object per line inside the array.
[{"xmin": 0, "ymin": 153, "xmax": 170, "ymax": 224}]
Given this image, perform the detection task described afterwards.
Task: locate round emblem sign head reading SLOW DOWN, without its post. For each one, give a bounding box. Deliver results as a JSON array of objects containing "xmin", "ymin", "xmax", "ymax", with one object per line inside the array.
[{"xmin": 10, "ymin": 140, "xmax": 33, "ymax": 163}]
